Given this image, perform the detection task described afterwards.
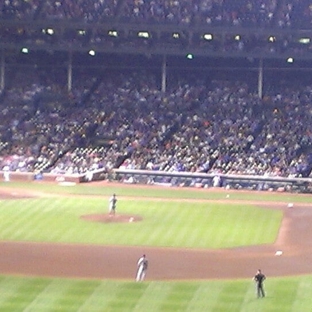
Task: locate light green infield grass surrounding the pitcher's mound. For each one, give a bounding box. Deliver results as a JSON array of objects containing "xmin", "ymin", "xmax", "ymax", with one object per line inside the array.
[{"xmin": 0, "ymin": 197, "xmax": 282, "ymax": 248}]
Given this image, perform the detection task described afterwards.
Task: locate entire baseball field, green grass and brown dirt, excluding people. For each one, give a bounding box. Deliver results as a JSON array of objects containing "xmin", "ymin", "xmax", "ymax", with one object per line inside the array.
[{"xmin": 0, "ymin": 181, "xmax": 312, "ymax": 312}]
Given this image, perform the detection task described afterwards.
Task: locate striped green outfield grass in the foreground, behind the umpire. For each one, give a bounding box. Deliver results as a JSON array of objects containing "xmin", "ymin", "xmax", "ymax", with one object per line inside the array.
[{"xmin": 0, "ymin": 276, "xmax": 312, "ymax": 312}]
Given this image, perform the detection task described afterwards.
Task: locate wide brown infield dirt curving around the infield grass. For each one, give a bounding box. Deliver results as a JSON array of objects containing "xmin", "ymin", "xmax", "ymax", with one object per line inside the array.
[{"xmin": 0, "ymin": 192, "xmax": 312, "ymax": 280}]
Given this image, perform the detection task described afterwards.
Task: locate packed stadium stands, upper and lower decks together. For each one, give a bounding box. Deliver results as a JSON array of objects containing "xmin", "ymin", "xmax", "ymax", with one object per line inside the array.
[{"xmin": 0, "ymin": 0, "xmax": 312, "ymax": 183}]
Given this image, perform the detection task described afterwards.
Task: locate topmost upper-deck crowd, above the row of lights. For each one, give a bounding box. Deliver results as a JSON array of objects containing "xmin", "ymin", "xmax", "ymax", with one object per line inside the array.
[{"xmin": 0, "ymin": 0, "xmax": 312, "ymax": 28}]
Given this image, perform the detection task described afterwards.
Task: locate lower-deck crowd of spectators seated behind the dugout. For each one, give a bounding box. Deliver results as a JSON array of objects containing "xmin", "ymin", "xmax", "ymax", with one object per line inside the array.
[{"xmin": 0, "ymin": 65, "xmax": 312, "ymax": 177}]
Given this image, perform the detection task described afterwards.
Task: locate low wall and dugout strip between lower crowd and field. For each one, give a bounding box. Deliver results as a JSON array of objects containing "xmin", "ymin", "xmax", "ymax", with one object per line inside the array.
[{"xmin": 0, "ymin": 169, "xmax": 312, "ymax": 193}]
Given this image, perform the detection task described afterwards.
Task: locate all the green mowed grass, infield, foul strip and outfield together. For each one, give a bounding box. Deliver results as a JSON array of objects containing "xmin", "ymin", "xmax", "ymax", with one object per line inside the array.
[{"xmin": 0, "ymin": 183, "xmax": 312, "ymax": 312}]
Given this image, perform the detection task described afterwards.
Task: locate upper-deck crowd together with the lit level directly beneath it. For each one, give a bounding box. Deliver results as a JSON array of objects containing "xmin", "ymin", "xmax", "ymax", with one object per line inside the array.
[{"xmin": 0, "ymin": 0, "xmax": 312, "ymax": 62}]
